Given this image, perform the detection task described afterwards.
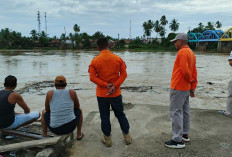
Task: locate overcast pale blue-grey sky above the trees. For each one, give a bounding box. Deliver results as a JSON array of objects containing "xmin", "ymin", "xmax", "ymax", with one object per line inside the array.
[{"xmin": 0, "ymin": 0, "xmax": 232, "ymax": 38}]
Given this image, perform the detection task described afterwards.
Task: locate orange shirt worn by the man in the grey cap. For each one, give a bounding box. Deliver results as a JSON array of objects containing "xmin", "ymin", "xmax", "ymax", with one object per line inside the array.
[{"xmin": 171, "ymin": 45, "xmax": 197, "ymax": 91}]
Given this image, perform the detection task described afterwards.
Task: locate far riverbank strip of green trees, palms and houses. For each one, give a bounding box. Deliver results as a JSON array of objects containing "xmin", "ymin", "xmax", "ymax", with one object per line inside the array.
[{"xmin": 0, "ymin": 15, "xmax": 222, "ymax": 51}]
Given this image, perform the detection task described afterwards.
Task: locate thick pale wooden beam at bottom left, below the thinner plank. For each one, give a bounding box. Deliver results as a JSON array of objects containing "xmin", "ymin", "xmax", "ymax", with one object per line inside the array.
[{"xmin": 0, "ymin": 136, "xmax": 62, "ymax": 153}]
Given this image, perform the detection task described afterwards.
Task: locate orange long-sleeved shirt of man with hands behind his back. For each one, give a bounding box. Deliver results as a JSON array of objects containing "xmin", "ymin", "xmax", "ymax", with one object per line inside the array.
[{"xmin": 89, "ymin": 50, "xmax": 127, "ymax": 97}]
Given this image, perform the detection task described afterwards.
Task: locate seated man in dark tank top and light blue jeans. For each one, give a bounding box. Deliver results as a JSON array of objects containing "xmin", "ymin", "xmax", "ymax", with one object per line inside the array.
[{"xmin": 0, "ymin": 75, "xmax": 40, "ymax": 130}]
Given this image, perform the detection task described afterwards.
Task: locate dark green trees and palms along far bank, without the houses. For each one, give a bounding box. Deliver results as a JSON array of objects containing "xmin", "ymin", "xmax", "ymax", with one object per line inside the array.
[{"xmin": 0, "ymin": 15, "xmax": 225, "ymax": 49}]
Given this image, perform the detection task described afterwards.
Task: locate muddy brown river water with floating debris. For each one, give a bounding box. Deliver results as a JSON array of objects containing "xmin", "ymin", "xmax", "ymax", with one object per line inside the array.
[{"xmin": 0, "ymin": 51, "xmax": 232, "ymax": 115}]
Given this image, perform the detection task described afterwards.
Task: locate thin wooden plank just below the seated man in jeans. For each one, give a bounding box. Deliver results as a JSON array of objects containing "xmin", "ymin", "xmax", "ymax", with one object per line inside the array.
[{"xmin": 0, "ymin": 129, "xmax": 46, "ymax": 139}]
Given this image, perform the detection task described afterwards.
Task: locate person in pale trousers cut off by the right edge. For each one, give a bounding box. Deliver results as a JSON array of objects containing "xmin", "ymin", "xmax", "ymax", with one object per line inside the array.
[{"xmin": 220, "ymin": 51, "xmax": 232, "ymax": 117}]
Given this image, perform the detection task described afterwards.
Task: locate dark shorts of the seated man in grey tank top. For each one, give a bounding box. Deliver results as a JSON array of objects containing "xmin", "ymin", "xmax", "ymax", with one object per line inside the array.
[{"xmin": 44, "ymin": 109, "xmax": 81, "ymax": 135}]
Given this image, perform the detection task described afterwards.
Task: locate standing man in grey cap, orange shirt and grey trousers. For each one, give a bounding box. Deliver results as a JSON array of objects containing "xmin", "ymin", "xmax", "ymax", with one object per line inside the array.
[{"xmin": 165, "ymin": 33, "xmax": 197, "ymax": 148}]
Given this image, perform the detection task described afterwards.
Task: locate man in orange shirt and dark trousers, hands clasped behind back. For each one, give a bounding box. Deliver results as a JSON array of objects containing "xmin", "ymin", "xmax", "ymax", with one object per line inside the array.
[{"xmin": 89, "ymin": 38, "xmax": 132, "ymax": 147}]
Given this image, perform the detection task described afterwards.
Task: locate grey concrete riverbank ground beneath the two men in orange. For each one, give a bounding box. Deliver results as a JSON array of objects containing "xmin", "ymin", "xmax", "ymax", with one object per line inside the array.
[{"xmin": 70, "ymin": 104, "xmax": 232, "ymax": 157}]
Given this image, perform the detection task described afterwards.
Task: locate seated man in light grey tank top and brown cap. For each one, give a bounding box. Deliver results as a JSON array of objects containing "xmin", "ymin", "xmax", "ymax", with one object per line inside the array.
[{"xmin": 41, "ymin": 76, "xmax": 84, "ymax": 140}]
